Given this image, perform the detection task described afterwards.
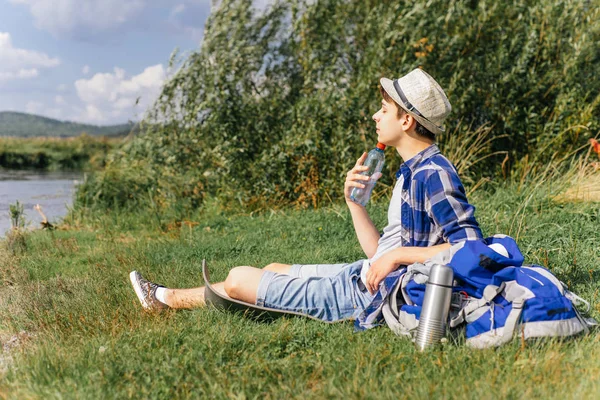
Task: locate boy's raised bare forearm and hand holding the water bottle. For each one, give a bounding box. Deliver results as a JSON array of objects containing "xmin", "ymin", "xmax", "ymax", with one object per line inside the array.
[{"xmin": 344, "ymin": 153, "xmax": 379, "ymax": 258}]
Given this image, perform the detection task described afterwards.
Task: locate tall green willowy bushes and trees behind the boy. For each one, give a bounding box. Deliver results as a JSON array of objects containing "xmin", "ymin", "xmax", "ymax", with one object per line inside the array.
[{"xmin": 75, "ymin": 0, "xmax": 600, "ymax": 209}]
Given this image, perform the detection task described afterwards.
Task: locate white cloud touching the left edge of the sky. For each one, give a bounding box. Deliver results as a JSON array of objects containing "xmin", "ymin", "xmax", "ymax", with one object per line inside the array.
[{"xmin": 0, "ymin": 32, "xmax": 60, "ymax": 81}]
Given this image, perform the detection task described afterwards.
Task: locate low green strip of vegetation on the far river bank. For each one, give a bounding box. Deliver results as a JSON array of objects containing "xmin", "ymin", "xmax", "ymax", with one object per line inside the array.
[{"xmin": 0, "ymin": 134, "xmax": 123, "ymax": 171}]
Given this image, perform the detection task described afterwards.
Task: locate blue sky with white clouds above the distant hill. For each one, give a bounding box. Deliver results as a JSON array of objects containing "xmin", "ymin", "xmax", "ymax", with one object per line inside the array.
[{"xmin": 0, "ymin": 0, "xmax": 216, "ymax": 125}]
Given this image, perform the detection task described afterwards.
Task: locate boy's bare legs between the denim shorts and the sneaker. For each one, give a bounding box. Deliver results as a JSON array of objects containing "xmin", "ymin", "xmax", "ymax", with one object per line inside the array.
[{"xmin": 159, "ymin": 263, "xmax": 291, "ymax": 308}]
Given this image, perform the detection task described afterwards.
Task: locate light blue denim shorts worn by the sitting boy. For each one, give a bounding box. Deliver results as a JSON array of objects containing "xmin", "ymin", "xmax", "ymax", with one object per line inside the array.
[{"xmin": 256, "ymin": 260, "xmax": 373, "ymax": 322}]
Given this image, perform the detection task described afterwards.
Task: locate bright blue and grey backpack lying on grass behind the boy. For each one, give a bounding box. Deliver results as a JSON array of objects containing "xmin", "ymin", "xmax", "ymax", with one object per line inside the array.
[{"xmin": 381, "ymin": 235, "xmax": 597, "ymax": 348}]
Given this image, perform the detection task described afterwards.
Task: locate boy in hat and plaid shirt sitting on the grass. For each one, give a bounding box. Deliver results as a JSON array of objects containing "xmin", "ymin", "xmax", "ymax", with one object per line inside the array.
[{"xmin": 130, "ymin": 69, "xmax": 482, "ymax": 321}]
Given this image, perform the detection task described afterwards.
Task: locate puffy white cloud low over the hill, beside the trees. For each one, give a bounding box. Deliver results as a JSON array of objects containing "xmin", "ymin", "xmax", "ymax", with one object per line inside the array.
[{"xmin": 75, "ymin": 64, "xmax": 166, "ymax": 123}]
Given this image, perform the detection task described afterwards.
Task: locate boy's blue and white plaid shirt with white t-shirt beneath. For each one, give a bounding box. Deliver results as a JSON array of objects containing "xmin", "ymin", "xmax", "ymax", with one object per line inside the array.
[{"xmin": 356, "ymin": 144, "xmax": 483, "ymax": 329}]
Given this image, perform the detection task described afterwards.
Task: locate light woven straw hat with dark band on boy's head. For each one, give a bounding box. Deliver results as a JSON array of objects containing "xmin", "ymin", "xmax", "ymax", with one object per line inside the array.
[{"xmin": 380, "ymin": 69, "xmax": 452, "ymax": 134}]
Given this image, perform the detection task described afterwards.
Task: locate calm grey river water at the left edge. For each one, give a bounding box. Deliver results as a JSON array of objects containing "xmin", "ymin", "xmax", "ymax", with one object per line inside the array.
[{"xmin": 0, "ymin": 170, "xmax": 83, "ymax": 237}]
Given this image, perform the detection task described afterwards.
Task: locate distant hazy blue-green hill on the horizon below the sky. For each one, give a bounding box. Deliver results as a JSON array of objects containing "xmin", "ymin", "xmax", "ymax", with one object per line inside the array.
[{"xmin": 0, "ymin": 111, "xmax": 134, "ymax": 137}]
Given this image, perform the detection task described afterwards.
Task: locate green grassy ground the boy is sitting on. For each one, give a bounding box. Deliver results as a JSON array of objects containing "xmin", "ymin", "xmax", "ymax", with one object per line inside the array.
[{"xmin": 0, "ymin": 180, "xmax": 600, "ymax": 399}]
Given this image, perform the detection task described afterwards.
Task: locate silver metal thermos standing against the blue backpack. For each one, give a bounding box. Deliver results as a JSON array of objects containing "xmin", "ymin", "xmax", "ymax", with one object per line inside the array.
[{"xmin": 416, "ymin": 264, "xmax": 454, "ymax": 351}]
